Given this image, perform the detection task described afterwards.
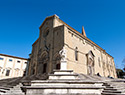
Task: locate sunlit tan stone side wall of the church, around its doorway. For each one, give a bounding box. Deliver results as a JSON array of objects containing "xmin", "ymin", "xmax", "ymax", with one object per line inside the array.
[{"xmin": 64, "ymin": 27, "xmax": 116, "ymax": 78}]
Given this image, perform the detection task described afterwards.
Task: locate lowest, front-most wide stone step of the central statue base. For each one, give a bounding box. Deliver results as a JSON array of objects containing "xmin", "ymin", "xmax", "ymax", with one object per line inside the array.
[{"xmin": 24, "ymin": 86, "xmax": 103, "ymax": 95}]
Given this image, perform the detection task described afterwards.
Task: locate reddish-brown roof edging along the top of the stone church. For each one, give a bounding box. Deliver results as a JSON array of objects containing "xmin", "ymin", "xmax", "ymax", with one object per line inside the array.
[{"xmin": 33, "ymin": 15, "xmax": 113, "ymax": 58}]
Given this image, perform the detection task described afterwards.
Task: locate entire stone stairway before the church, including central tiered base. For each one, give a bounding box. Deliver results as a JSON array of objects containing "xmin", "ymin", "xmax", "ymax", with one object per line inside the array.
[{"xmin": 0, "ymin": 70, "xmax": 125, "ymax": 95}]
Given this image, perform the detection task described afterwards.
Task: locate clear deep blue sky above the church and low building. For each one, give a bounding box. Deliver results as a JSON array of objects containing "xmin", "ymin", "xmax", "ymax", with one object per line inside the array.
[{"xmin": 0, "ymin": 0, "xmax": 125, "ymax": 68}]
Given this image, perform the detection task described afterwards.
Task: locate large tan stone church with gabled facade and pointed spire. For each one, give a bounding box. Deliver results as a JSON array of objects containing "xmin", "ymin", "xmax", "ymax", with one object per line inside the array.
[{"xmin": 28, "ymin": 15, "xmax": 117, "ymax": 78}]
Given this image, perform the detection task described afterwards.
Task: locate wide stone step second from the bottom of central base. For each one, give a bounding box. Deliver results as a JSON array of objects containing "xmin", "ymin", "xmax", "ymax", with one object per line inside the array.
[{"xmin": 31, "ymin": 80, "xmax": 103, "ymax": 87}]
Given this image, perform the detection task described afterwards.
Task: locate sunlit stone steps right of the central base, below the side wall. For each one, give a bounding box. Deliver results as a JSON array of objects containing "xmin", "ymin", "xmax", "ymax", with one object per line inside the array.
[{"xmin": 79, "ymin": 74, "xmax": 125, "ymax": 95}]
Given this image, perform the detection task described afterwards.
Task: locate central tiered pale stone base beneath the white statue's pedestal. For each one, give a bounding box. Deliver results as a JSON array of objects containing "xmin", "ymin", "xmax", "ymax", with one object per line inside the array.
[{"xmin": 23, "ymin": 70, "xmax": 105, "ymax": 95}]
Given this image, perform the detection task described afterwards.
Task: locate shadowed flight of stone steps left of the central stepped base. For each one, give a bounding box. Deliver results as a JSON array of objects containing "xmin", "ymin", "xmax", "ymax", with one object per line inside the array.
[{"xmin": 0, "ymin": 77, "xmax": 24, "ymax": 95}]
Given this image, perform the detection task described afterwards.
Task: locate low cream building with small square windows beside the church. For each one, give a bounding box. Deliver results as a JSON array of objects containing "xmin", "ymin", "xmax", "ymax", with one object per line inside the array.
[{"xmin": 0, "ymin": 54, "xmax": 27, "ymax": 79}]
